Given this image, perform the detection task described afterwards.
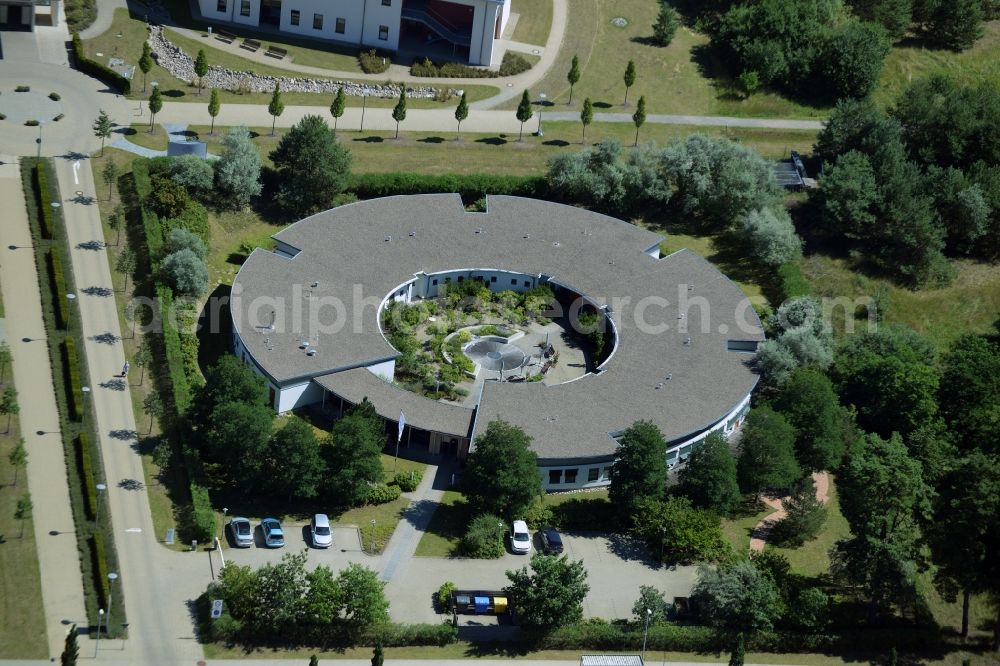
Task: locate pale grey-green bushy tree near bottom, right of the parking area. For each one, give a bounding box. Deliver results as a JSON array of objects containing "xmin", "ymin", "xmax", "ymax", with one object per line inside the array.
[{"xmin": 691, "ymin": 560, "xmax": 782, "ymax": 635}]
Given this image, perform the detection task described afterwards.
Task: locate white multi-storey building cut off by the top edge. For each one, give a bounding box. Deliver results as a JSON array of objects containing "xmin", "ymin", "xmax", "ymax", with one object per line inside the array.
[{"xmin": 198, "ymin": 0, "xmax": 510, "ymax": 66}]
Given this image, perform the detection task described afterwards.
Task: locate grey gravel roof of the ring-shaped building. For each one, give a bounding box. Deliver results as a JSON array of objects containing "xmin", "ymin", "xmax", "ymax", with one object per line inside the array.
[{"xmin": 232, "ymin": 195, "xmax": 764, "ymax": 459}]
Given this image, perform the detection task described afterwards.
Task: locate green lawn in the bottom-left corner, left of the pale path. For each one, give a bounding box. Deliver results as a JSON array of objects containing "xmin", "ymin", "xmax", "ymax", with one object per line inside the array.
[{"xmin": 0, "ymin": 408, "xmax": 48, "ymax": 659}]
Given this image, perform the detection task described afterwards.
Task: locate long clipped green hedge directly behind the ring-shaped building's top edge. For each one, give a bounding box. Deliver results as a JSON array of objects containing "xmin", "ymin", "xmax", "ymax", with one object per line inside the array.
[{"xmin": 347, "ymin": 173, "xmax": 548, "ymax": 202}]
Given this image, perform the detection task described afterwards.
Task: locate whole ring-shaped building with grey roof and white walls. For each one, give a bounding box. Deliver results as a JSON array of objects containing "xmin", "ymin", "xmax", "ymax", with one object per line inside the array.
[{"xmin": 230, "ymin": 195, "xmax": 764, "ymax": 490}]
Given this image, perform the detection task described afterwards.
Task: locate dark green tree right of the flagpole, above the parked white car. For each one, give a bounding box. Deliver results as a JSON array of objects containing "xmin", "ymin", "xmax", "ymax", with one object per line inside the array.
[{"xmin": 462, "ymin": 420, "xmax": 542, "ymax": 521}]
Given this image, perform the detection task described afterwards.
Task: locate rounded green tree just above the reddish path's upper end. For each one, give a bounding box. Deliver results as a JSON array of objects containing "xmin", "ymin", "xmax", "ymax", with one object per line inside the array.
[{"xmin": 774, "ymin": 368, "xmax": 846, "ymax": 472}]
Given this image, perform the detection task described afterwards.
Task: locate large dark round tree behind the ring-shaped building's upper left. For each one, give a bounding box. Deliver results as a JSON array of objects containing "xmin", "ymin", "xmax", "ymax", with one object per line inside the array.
[{"xmin": 271, "ymin": 115, "xmax": 351, "ymax": 216}]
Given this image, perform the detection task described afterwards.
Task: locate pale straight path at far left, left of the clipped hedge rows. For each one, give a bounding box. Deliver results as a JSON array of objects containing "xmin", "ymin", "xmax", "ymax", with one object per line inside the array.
[{"xmin": 0, "ymin": 156, "xmax": 87, "ymax": 656}]
